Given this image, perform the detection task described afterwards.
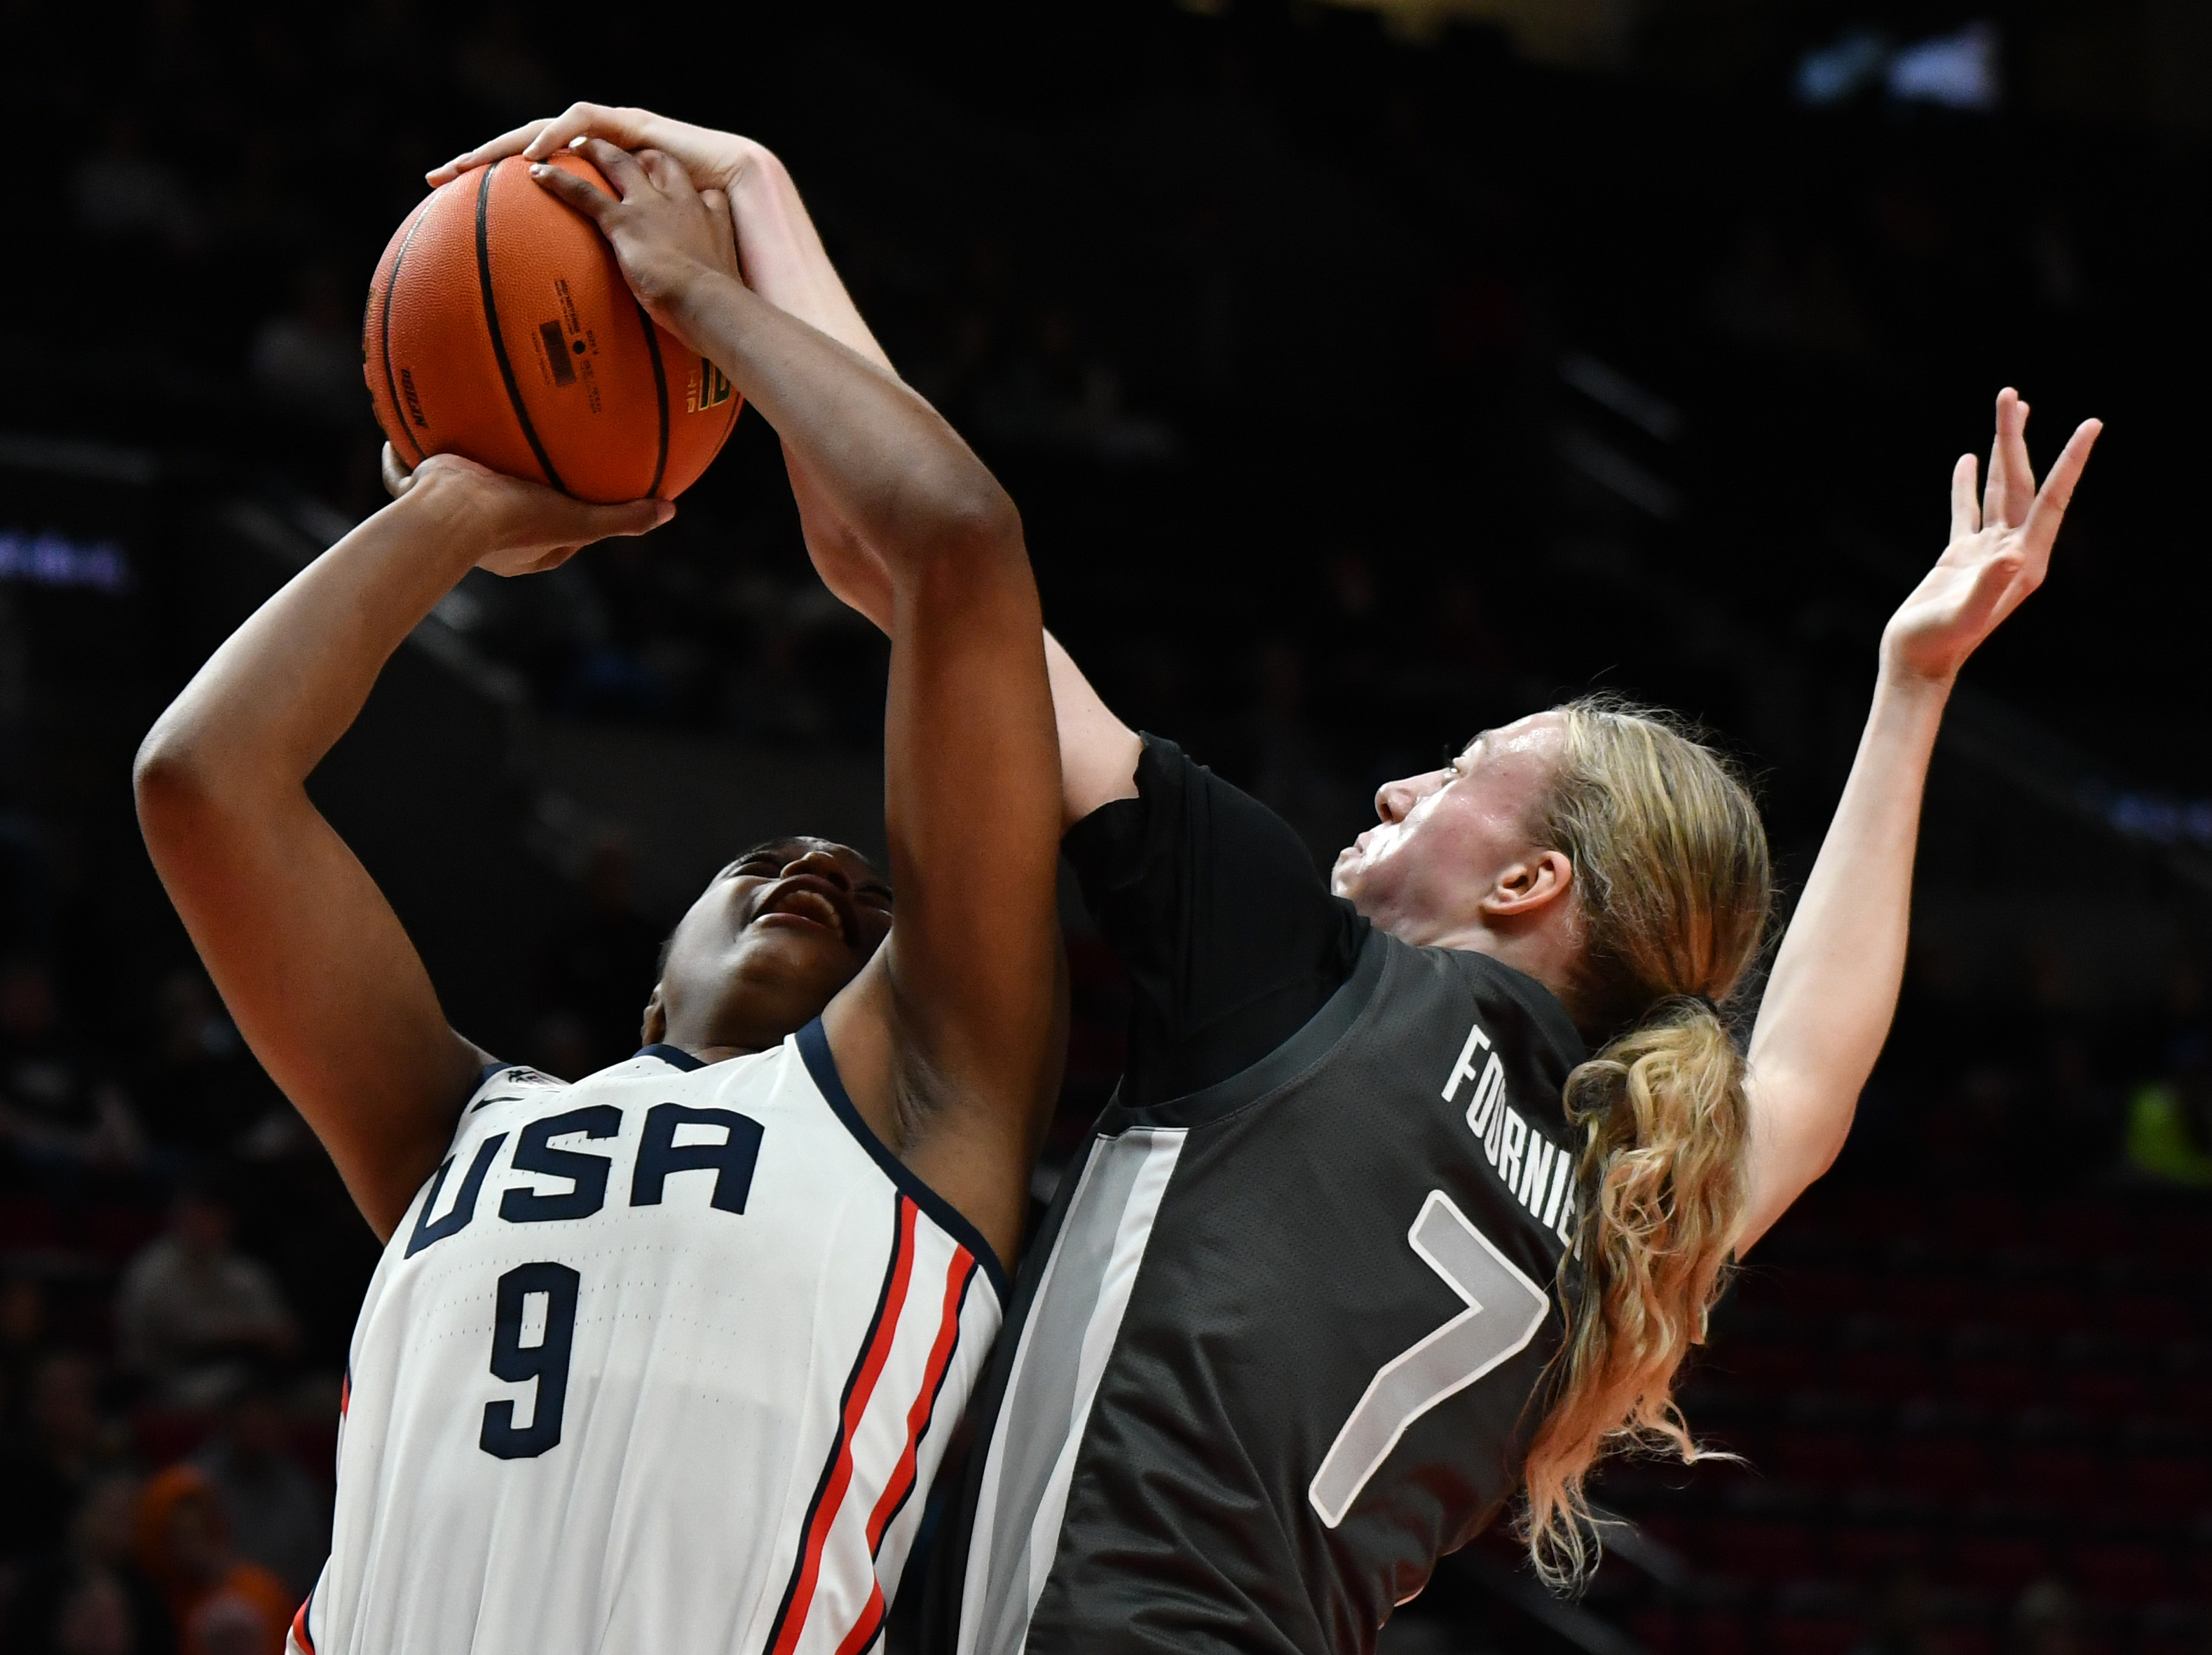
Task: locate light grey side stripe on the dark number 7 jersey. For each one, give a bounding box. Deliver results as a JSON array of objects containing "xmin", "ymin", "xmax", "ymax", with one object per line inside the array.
[{"xmin": 960, "ymin": 1129, "xmax": 1183, "ymax": 1655}]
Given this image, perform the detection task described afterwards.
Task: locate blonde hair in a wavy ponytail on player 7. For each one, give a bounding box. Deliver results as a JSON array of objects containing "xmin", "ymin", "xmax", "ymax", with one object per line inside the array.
[{"xmin": 1522, "ymin": 699, "xmax": 1774, "ymax": 1586}]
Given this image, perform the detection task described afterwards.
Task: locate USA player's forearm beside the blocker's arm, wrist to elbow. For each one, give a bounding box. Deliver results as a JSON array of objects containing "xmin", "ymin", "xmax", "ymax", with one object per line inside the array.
[{"xmin": 679, "ymin": 274, "xmax": 1026, "ymax": 589}]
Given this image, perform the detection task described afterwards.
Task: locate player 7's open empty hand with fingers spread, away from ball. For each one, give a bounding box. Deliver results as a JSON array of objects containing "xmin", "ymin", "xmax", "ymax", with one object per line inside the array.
[{"xmin": 1883, "ymin": 387, "xmax": 2103, "ymax": 683}]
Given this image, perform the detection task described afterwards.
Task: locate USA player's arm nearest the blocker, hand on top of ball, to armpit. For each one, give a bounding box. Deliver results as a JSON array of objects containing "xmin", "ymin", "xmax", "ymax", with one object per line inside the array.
[{"xmin": 535, "ymin": 139, "xmax": 1060, "ymax": 1259}]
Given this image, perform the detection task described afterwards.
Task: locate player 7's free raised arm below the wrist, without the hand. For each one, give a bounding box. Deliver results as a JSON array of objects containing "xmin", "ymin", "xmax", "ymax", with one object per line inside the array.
[{"xmin": 1749, "ymin": 670, "xmax": 1951, "ymax": 1234}]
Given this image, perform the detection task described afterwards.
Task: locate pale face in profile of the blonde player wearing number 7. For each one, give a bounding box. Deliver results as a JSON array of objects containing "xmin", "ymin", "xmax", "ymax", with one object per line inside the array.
[{"xmin": 1330, "ymin": 712, "xmax": 1566, "ymax": 947}]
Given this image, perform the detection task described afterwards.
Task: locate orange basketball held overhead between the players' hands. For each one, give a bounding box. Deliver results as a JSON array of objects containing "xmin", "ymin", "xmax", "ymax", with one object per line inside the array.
[{"xmin": 360, "ymin": 151, "xmax": 741, "ymax": 503}]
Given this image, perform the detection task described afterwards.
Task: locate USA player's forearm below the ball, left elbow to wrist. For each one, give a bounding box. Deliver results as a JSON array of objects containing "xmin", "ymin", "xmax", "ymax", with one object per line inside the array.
[{"xmin": 139, "ymin": 480, "xmax": 482, "ymax": 805}]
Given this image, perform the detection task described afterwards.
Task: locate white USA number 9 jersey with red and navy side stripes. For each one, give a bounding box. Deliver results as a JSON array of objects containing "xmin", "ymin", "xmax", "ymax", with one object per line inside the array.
[{"xmin": 292, "ymin": 1020, "xmax": 1004, "ymax": 1655}]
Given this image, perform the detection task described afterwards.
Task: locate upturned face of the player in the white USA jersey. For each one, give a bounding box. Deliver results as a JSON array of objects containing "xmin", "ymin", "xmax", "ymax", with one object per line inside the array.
[{"xmin": 657, "ymin": 838, "xmax": 892, "ymax": 1049}]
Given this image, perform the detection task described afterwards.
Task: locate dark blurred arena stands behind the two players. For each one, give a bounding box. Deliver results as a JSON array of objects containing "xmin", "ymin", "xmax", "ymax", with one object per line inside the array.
[{"xmin": 0, "ymin": 0, "xmax": 2212, "ymax": 1655}]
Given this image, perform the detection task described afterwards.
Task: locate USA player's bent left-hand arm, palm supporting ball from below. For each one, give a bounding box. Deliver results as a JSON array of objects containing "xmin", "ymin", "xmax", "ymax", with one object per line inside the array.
[{"xmin": 137, "ymin": 449, "xmax": 672, "ymax": 1237}]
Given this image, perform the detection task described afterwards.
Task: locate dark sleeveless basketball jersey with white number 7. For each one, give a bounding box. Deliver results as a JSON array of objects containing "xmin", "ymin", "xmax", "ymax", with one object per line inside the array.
[{"xmin": 924, "ymin": 915, "xmax": 1586, "ymax": 1655}]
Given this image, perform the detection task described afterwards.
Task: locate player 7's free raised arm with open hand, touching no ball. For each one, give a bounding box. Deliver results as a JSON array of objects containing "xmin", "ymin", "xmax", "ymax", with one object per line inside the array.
[{"xmin": 1741, "ymin": 390, "xmax": 2103, "ymax": 1248}]
